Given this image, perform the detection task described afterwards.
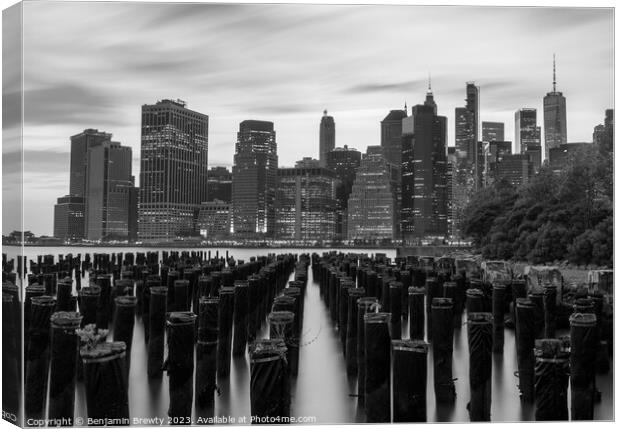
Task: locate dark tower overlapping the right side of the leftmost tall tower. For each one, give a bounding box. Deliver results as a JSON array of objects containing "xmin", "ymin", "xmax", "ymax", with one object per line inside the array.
[{"xmin": 84, "ymin": 141, "xmax": 134, "ymax": 240}]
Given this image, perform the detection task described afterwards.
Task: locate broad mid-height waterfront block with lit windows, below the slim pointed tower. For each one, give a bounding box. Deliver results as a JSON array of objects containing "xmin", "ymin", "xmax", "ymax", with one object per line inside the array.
[{"xmin": 275, "ymin": 158, "xmax": 338, "ymax": 241}]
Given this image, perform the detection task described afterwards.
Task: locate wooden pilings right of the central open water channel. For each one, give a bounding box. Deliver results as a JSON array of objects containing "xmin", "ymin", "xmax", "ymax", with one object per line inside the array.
[{"xmin": 312, "ymin": 252, "xmax": 609, "ymax": 423}]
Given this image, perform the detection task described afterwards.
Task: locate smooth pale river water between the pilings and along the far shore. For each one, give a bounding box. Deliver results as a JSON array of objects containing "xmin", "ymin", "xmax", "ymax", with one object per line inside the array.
[{"xmin": 3, "ymin": 246, "xmax": 614, "ymax": 424}]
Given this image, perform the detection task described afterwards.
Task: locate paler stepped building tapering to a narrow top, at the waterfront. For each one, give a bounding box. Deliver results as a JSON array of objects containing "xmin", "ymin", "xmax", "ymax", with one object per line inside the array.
[{"xmin": 347, "ymin": 146, "xmax": 399, "ymax": 242}]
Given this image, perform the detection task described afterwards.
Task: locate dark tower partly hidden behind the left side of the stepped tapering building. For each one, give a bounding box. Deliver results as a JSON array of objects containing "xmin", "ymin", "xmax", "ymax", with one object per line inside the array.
[{"xmin": 327, "ymin": 145, "xmax": 362, "ymax": 240}]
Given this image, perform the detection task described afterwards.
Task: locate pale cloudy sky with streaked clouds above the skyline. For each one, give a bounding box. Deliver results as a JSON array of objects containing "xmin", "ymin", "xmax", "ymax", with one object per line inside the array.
[{"xmin": 3, "ymin": 1, "xmax": 614, "ymax": 235}]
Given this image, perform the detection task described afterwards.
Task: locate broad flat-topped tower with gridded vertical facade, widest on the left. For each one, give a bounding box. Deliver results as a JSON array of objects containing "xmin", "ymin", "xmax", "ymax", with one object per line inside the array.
[{"xmin": 138, "ymin": 100, "xmax": 209, "ymax": 241}]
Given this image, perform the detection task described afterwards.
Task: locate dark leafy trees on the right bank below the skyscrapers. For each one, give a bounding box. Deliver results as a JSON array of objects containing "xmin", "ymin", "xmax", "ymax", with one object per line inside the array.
[{"xmin": 461, "ymin": 144, "xmax": 613, "ymax": 266}]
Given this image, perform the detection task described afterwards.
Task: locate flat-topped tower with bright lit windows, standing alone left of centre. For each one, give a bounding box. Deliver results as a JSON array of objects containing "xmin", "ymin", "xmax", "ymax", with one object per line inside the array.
[{"xmin": 232, "ymin": 120, "xmax": 278, "ymax": 238}]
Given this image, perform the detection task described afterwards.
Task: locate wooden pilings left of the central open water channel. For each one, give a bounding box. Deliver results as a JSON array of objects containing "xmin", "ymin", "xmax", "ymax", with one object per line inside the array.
[{"xmin": 3, "ymin": 252, "xmax": 309, "ymax": 426}]
